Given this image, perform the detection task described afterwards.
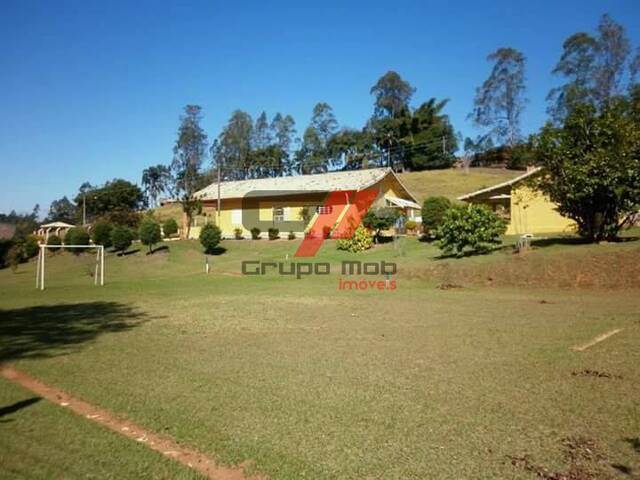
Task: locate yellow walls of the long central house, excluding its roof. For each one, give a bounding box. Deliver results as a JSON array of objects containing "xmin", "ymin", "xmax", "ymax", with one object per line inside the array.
[{"xmin": 189, "ymin": 175, "xmax": 412, "ymax": 238}]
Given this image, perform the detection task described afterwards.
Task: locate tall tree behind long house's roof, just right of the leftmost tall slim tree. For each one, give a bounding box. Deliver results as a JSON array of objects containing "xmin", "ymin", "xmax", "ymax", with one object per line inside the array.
[{"xmin": 215, "ymin": 110, "xmax": 255, "ymax": 180}]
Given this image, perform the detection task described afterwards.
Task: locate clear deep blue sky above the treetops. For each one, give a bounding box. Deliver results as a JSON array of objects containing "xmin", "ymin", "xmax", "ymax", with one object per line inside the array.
[{"xmin": 0, "ymin": 0, "xmax": 640, "ymax": 213}]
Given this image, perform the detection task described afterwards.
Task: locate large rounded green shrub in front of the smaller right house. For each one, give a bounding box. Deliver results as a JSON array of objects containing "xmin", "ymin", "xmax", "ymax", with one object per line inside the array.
[{"xmin": 437, "ymin": 205, "xmax": 507, "ymax": 256}]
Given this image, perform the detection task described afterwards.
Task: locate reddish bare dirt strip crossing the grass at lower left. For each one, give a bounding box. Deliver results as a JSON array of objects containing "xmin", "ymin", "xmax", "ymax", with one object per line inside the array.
[{"xmin": 0, "ymin": 365, "xmax": 266, "ymax": 480}]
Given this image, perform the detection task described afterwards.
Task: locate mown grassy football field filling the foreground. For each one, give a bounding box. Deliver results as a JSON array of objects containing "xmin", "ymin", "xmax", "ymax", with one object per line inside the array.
[{"xmin": 0, "ymin": 237, "xmax": 640, "ymax": 479}]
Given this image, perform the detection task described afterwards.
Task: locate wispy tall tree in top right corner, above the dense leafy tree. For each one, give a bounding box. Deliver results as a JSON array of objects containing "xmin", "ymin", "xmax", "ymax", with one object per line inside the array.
[{"xmin": 547, "ymin": 15, "xmax": 640, "ymax": 124}]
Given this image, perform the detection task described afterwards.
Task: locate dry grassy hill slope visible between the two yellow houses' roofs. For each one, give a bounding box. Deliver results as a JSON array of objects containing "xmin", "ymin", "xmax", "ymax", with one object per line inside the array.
[{"xmin": 399, "ymin": 168, "xmax": 523, "ymax": 202}]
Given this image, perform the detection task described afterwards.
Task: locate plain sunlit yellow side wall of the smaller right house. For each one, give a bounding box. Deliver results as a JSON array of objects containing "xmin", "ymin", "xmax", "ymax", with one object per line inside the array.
[{"xmin": 507, "ymin": 186, "xmax": 575, "ymax": 235}]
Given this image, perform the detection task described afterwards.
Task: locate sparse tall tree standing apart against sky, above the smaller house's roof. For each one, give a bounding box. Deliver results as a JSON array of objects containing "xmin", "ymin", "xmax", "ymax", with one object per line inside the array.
[{"xmin": 469, "ymin": 48, "xmax": 526, "ymax": 147}]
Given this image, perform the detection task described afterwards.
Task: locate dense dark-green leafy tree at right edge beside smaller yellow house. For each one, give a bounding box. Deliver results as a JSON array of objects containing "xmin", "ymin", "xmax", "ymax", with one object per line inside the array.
[{"xmin": 536, "ymin": 97, "xmax": 640, "ymax": 242}]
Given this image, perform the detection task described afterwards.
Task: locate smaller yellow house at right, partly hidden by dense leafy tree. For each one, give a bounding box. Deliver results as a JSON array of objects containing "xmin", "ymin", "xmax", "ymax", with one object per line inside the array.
[{"xmin": 458, "ymin": 168, "xmax": 575, "ymax": 235}]
